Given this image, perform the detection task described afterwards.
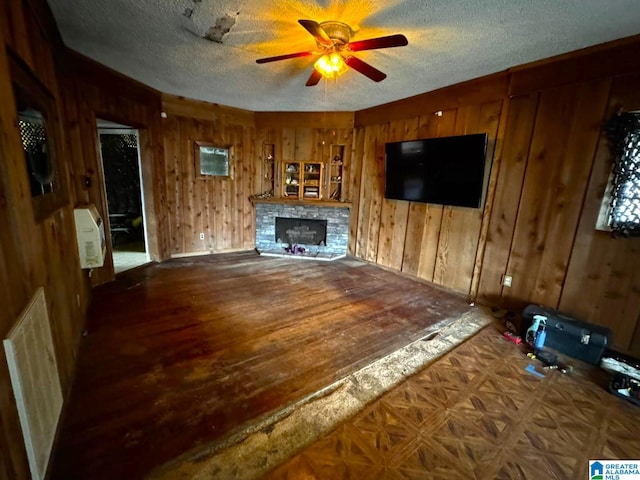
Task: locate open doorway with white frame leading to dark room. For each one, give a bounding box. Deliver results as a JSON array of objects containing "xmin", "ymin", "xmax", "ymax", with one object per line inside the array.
[{"xmin": 97, "ymin": 119, "xmax": 149, "ymax": 274}]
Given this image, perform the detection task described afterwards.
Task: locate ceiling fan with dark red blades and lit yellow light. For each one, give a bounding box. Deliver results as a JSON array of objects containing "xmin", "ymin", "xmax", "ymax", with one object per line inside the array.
[{"xmin": 256, "ymin": 20, "xmax": 409, "ymax": 87}]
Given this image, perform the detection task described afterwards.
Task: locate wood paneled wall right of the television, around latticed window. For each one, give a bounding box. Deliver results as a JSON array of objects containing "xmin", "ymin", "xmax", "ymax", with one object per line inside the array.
[{"xmin": 478, "ymin": 49, "xmax": 640, "ymax": 355}]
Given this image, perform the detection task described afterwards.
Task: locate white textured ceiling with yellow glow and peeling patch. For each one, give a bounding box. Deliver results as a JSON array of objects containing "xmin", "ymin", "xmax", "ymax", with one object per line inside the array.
[{"xmin": 48, "ymin": 0, "xmax": 640, "ymax": 111}]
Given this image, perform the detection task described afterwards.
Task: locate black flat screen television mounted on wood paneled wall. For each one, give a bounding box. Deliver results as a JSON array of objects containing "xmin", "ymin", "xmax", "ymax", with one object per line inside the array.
[{"xmin": 384, "ymin": 133, "xmax": 487, "ymax": 208}]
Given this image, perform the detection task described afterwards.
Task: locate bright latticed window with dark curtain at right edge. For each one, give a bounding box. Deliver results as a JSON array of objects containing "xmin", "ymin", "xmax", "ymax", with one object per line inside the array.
[{"xmin": 597, "ymin": 112, "xmax": 640, "ymax": 237}]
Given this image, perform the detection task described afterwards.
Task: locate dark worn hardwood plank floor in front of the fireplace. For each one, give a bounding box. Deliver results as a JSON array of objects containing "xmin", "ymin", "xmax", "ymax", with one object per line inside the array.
[{"xmin": 51, "ymin": 252, "xmax": 469, "ymax": 480}]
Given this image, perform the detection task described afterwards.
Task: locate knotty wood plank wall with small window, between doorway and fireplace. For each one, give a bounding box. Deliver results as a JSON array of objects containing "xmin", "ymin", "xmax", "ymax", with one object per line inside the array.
[{"xmin": 162, "ymin": 95, "xmax": 262, "ymax": 256}]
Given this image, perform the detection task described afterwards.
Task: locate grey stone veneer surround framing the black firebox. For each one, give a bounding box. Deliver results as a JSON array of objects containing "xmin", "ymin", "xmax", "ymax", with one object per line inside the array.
[{"xmin": 255, "ymin": 200, "xmax": 349, "ymax": 259}]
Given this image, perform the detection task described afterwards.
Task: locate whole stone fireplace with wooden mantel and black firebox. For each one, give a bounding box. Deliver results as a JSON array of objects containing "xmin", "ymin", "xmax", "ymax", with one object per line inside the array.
[{"xmin": 254, "ymin": 199, "xmax": 349, "ymax": 260}]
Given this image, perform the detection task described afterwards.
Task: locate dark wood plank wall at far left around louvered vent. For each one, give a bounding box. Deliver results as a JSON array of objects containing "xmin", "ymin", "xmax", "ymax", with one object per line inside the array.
[{"xmin": 0, "ymin": 0, "xmax": 90, "ymax": 480}]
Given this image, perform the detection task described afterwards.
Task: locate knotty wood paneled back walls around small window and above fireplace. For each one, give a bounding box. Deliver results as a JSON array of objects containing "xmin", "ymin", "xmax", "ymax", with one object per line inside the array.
[{"xmin": 162, "ymin": 102, "xmax": 353, "ymax": 256}]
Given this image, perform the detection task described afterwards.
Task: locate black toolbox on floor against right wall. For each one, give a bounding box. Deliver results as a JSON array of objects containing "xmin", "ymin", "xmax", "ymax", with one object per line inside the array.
[{"xmin": 522, "ymin": 305, "xmax": 611, "ymax": 365}]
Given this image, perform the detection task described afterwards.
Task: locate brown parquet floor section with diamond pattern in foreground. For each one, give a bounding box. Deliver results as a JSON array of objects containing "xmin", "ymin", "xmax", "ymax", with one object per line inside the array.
[{"xmin": 264, "ymin": 326, "xmax": 640, "ymax": 480}]
